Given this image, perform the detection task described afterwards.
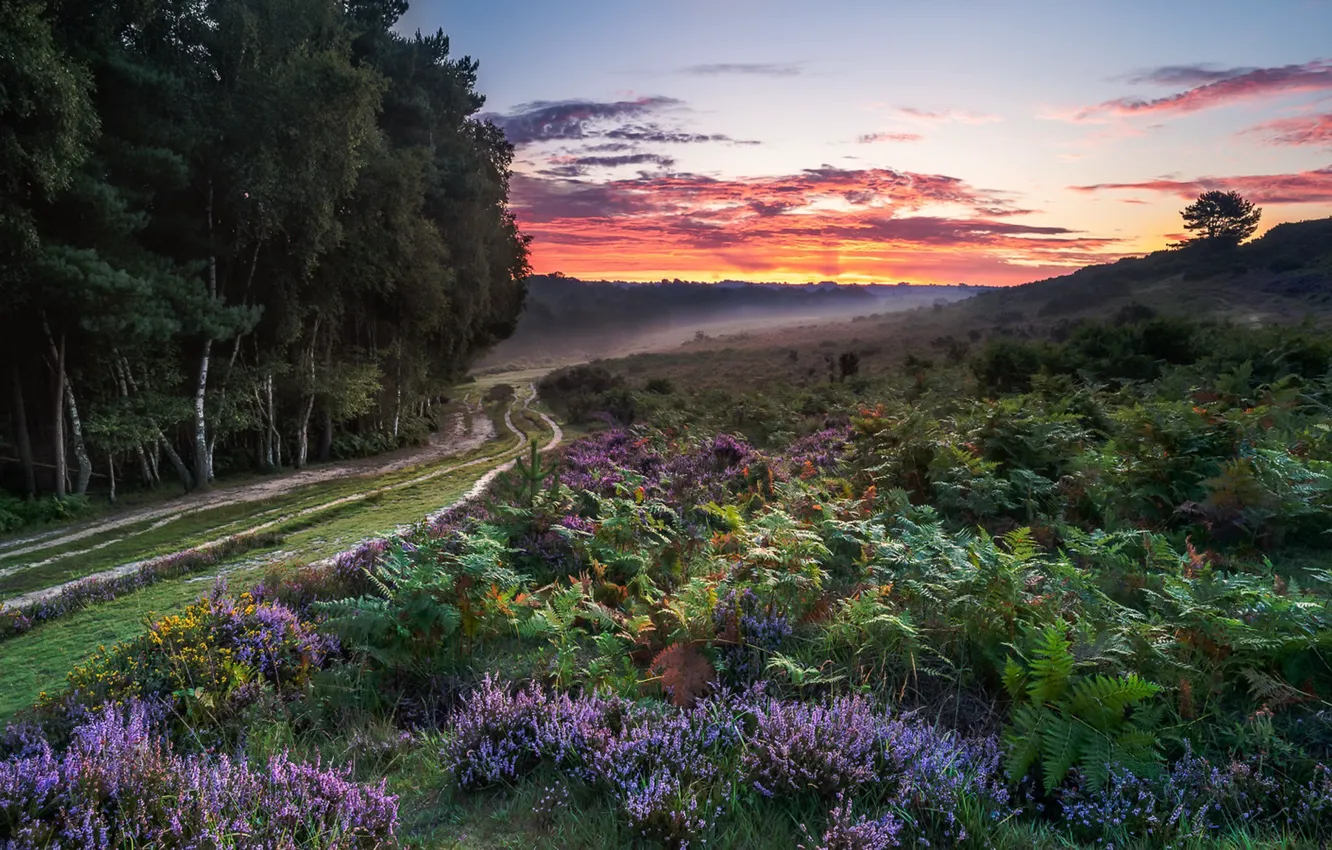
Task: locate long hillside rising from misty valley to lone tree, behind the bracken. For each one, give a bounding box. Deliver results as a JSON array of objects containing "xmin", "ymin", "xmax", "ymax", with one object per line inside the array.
[{"xmin": 578, "ymin": 218, "xmax": 1332, "ymax": 392}]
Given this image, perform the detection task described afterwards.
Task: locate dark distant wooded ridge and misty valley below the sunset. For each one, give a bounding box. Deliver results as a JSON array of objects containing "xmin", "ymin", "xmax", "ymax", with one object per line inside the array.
[{"xmin": 481, "ymin": 274, "xmax": 986, "ymax": 369}]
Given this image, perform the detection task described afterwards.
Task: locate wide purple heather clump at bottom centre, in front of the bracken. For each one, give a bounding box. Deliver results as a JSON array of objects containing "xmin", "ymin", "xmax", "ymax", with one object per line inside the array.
[{"xmin": 442, "ymin": 677, "xmax": 1012, "ymax": 849}]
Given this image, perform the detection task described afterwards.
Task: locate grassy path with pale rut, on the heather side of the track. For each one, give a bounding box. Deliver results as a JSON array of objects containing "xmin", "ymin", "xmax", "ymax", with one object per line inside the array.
[{"xmin": 0, "ymin": 383, "xmax": 563, "ymax": 722}]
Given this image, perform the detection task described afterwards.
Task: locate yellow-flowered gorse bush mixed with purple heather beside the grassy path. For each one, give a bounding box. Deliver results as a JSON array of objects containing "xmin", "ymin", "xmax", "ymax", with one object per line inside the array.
[{"xmin": 55, "ymin": 586, "xmax": 338, "ymax": 722}]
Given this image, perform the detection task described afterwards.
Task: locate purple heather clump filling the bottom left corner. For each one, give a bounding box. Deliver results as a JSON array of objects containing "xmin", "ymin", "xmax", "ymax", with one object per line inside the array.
[{"xmin": 0, "ymin": 702, "xmax": 397, "ymax": 850}]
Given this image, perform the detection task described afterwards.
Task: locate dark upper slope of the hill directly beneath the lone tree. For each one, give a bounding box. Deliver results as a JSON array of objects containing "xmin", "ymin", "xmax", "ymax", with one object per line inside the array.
[{"xmin": 948, "ymin": 218, "xmax": 1332, "ymax": 324}]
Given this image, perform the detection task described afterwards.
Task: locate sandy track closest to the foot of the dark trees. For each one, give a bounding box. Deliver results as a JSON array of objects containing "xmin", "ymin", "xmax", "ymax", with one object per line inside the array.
[{"xmin": 0, "ymin": 406, "xmax": 496, "ymax": 576}]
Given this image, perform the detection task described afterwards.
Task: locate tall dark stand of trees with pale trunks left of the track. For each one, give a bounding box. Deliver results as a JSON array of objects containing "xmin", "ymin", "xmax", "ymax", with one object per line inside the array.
[{"xmin": 0, "ymin": 0, "xmax": 529, "ymax": 496}]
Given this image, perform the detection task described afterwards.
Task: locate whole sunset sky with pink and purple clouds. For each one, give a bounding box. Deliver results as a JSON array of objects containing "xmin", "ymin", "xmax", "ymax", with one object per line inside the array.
[{"xmin": 398, "ymin": 0, "xmax": 1332, "ymax": 285}]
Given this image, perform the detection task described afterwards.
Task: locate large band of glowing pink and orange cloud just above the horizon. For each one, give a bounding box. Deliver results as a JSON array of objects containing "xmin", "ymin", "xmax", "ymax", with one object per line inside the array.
[{"xmin": 513, "ymin": 165, "xmax": 1123, "ymax": 284}]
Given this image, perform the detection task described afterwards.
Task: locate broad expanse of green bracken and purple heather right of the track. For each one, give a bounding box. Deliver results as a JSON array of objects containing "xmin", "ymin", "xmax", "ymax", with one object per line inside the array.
[{"xmin": 7, "ymin": 318, "xmax": 1332, "ymax": 850}]
